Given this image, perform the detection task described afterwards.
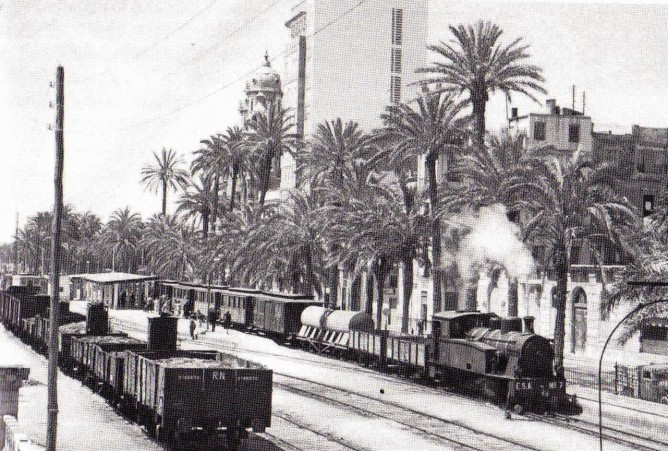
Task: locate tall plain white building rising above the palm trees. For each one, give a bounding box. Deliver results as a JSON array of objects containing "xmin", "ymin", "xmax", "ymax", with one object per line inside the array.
[{"xmin": 281, "ymin": 0, "xmax": 428, "ymax": 189}]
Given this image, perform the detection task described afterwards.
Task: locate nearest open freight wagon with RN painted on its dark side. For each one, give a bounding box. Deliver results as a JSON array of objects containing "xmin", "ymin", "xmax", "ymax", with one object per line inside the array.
[{"xmin": 123, "ymin": 350, "xmax": 273, "ymax": 443}]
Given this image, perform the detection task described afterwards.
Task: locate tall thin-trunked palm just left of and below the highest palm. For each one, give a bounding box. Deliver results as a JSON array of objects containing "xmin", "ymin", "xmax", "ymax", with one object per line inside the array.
[{"xmin": 376, "ymin": 92, "xmax": 463, "ymax": 316}]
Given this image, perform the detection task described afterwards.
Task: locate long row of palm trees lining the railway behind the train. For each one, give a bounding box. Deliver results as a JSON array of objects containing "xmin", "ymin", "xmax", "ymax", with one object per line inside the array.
[{"xmin": 6, "ymin": 22, "xmax": 639, "ymax": 365}]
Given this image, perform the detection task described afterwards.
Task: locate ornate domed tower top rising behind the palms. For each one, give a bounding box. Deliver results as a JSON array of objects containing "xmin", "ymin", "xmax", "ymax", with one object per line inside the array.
[{"xmin": 239, "ymin": 53, "xmax": 283, "ymax": 128}]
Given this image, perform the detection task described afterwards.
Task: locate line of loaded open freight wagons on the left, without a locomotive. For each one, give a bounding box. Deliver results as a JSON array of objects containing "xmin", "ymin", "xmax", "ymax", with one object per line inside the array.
[{"xmin": 0, "ymin": 287, "xmax": 273, "ymax": 449}]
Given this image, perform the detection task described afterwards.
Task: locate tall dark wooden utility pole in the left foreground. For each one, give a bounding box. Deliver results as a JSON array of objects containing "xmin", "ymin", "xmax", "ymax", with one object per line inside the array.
[{"xmin": 46, "ymin": 66, "xmax": 65, "ymax": 451}]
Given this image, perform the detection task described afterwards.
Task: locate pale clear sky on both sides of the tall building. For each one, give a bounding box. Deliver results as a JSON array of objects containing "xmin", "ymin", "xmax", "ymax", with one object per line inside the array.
[{"xmin": 0, "ymin": 0, "xmax": 668, "ymax": 243}]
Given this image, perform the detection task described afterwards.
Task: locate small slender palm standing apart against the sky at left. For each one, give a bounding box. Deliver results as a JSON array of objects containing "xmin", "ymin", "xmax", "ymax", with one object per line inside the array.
[{"xmin": 140, "ymin": 147, "xmax": 188, "ymax": 215}]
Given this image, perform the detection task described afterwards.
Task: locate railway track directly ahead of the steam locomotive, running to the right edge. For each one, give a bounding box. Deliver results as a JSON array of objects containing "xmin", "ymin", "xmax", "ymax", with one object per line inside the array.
[{"xmin": 527, "ymin": 414, "xmax": 668, "ymax": 451}]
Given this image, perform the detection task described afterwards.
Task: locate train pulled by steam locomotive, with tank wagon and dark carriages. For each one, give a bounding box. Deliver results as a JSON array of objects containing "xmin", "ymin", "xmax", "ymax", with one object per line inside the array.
[{"xmin": 156, "ymin": 281, "xmax": 582, "ymax": 414}]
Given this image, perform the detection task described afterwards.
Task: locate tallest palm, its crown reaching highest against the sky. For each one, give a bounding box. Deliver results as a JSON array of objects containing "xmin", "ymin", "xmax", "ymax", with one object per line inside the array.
[{"xmin": 418, "ymin": 21, "xmax": 546, "ymax": 146}]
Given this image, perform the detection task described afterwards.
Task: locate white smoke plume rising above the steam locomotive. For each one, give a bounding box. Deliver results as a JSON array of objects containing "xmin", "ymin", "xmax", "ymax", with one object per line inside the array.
[{"xmin": 453, "ymin": 204, "xmax": 535, "ymax": 280}]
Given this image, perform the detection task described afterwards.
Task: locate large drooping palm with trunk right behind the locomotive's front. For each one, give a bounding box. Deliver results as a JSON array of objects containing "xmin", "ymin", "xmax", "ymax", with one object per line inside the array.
[{"xmin": 504, "ymin": 152, "xmax": 637, "ymax": 368}]
